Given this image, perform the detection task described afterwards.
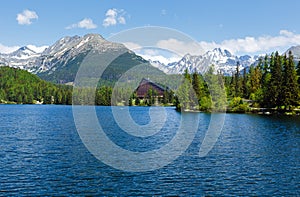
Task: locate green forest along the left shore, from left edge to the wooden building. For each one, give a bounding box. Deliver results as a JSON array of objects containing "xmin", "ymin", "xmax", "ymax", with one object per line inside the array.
[{"xmin": 0, "ymin": 66, "xmax": 174, "ymax": 106}]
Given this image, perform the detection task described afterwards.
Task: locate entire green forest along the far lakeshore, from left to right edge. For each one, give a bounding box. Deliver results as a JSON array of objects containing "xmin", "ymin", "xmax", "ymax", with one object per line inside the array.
[{"xmin": 0, "ymin": 52, "xmax": 300, "ymax": 112}]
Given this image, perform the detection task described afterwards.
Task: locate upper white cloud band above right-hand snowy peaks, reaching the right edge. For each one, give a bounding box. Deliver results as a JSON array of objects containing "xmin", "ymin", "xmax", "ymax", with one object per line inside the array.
[{"xmin": 157, "ymin": 30, "xmax": 300, "ymax": 55}]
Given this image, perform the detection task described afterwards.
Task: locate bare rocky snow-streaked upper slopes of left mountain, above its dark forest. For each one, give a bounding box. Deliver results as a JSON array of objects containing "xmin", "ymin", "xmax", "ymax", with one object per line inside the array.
[{"xmin": 0, "ymin": 34, "xmax": 129, "ymax": 74}]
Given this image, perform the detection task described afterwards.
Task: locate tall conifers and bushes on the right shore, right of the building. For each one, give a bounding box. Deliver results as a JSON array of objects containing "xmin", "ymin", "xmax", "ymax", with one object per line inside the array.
[{"xmin": 176, "ymin": 52, "xmax": 300, "ymax": 112}]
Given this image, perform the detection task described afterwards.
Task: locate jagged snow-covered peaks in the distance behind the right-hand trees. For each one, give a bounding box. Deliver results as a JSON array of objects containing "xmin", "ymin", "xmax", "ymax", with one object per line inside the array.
[{"xmin": 151, "ymin": 48, "xmax": 258, "ymax": 75}]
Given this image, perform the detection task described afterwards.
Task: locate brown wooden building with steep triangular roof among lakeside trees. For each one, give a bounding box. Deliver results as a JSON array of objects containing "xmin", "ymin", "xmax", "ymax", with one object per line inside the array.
[{"xmin": 136, "ymin": 78, "xmax": 166, "ymax": 99}]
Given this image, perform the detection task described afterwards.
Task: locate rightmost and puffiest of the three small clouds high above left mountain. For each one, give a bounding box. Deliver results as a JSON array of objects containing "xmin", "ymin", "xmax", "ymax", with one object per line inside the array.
[{"xmin": 103, "ymin": 8, "xmax": 126, "ymax": 27}]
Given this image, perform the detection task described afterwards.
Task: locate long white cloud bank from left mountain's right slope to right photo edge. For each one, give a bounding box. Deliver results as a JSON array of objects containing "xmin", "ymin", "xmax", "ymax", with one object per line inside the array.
[{"xmin": 117, "ymin": 30, "xmax": 300, "ymax": 63}]
